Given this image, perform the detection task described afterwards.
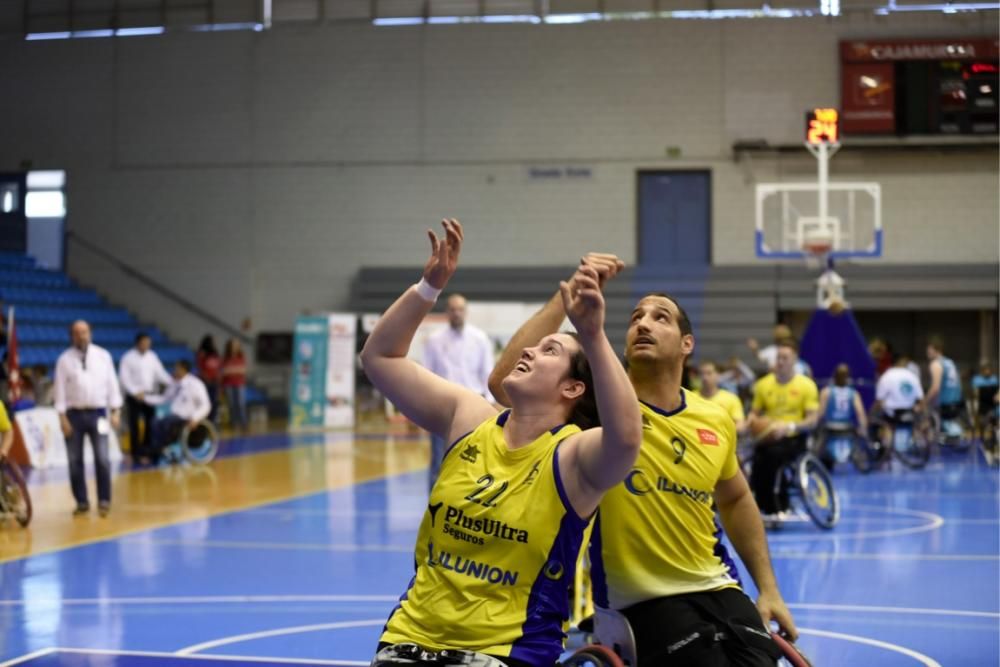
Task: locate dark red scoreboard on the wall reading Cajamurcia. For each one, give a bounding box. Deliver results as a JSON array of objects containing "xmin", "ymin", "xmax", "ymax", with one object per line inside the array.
[{"xmin": 840, "ymin": 38, "xmax": 1000, "ymax": 136}]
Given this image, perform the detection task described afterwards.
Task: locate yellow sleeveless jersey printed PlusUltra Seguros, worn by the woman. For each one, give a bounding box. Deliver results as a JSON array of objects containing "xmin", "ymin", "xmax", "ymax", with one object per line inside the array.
[{"xmin": 381, "ymin": 411, "xmax": 591, "ymax": 665}]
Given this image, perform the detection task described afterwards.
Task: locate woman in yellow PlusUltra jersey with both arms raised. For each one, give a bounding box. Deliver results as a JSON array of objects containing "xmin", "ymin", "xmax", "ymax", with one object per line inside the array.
[{"xmin": 361, "ymin": 220, "xmax": 642, "ymax": 667}]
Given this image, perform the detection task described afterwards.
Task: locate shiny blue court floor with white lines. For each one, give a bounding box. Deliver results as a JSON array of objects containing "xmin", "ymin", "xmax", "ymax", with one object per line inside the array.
[{"xmin": 0, "ymin": 442, "xmax": 1000, "ymax": 667}]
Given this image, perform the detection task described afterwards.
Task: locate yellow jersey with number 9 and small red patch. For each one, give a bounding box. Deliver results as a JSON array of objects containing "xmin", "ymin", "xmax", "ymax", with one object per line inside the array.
[{"xmin": 590, "ymin": 389, "xmax": 739, "ymax": 609}]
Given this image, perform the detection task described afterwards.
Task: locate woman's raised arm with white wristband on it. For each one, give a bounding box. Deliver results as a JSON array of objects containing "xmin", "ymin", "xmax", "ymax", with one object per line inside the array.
[{"xmin": 361, "ymin": 219, "xmax": 496, "ymax": 440}]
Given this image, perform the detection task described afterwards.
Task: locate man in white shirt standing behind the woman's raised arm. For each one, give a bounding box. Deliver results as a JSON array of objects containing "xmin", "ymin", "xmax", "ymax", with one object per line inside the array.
[{"xmin": 424, "ymin": 294, "xmax": 493, "ymax": 488}]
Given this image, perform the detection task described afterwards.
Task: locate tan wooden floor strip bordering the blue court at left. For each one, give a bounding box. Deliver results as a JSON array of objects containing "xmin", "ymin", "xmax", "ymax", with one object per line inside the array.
[{"xmin": 0, "ymin": 437, "xmax": 428, "ymax": 563}]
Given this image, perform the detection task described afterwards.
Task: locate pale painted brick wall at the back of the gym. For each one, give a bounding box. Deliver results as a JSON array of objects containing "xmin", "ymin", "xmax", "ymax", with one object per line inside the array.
[{"xmin": 0, "ymin": 13, "xmax": 1000, "ymax": 339}]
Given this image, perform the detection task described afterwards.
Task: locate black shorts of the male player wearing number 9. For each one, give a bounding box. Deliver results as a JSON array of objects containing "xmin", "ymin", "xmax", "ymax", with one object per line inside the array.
[{"xmin": 622, "ymin": 588, "xmax": 781, "ymax": 667}]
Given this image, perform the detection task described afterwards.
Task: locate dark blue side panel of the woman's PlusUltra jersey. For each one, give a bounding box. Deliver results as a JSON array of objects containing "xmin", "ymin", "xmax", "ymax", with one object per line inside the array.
[{"xmin": 510, "ymin": 446, "xmax": 587, "ymax": 665}]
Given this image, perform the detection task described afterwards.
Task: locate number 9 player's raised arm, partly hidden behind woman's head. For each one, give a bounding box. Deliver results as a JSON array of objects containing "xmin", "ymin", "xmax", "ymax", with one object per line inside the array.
[{"xmin": 489, "ymin": 252, "xmax": 625, "ymax": 407}]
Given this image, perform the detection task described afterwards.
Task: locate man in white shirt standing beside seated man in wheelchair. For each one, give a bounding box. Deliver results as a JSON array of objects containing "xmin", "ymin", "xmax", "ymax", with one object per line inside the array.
[{"xmin": 118, "ymin": 333, "xmax": 173, "ymax": 461}]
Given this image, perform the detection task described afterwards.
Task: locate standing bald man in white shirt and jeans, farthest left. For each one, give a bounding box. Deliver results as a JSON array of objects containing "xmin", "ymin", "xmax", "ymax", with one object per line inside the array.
[{"xmin": 54, "ymin": 320, "xmax": 122, "ymax": 517}]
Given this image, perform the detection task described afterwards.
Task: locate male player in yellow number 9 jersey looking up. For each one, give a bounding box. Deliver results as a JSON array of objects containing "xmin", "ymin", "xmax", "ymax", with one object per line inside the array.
[{"xmin": 490, "ymin": 254, "xmax": 797, "ymax": 666}]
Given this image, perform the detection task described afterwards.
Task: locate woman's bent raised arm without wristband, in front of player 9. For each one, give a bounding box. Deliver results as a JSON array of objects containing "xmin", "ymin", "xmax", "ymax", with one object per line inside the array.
[{"xmin": 559, "ymin": 264, "xmax": 642, "ymax": 516}]
